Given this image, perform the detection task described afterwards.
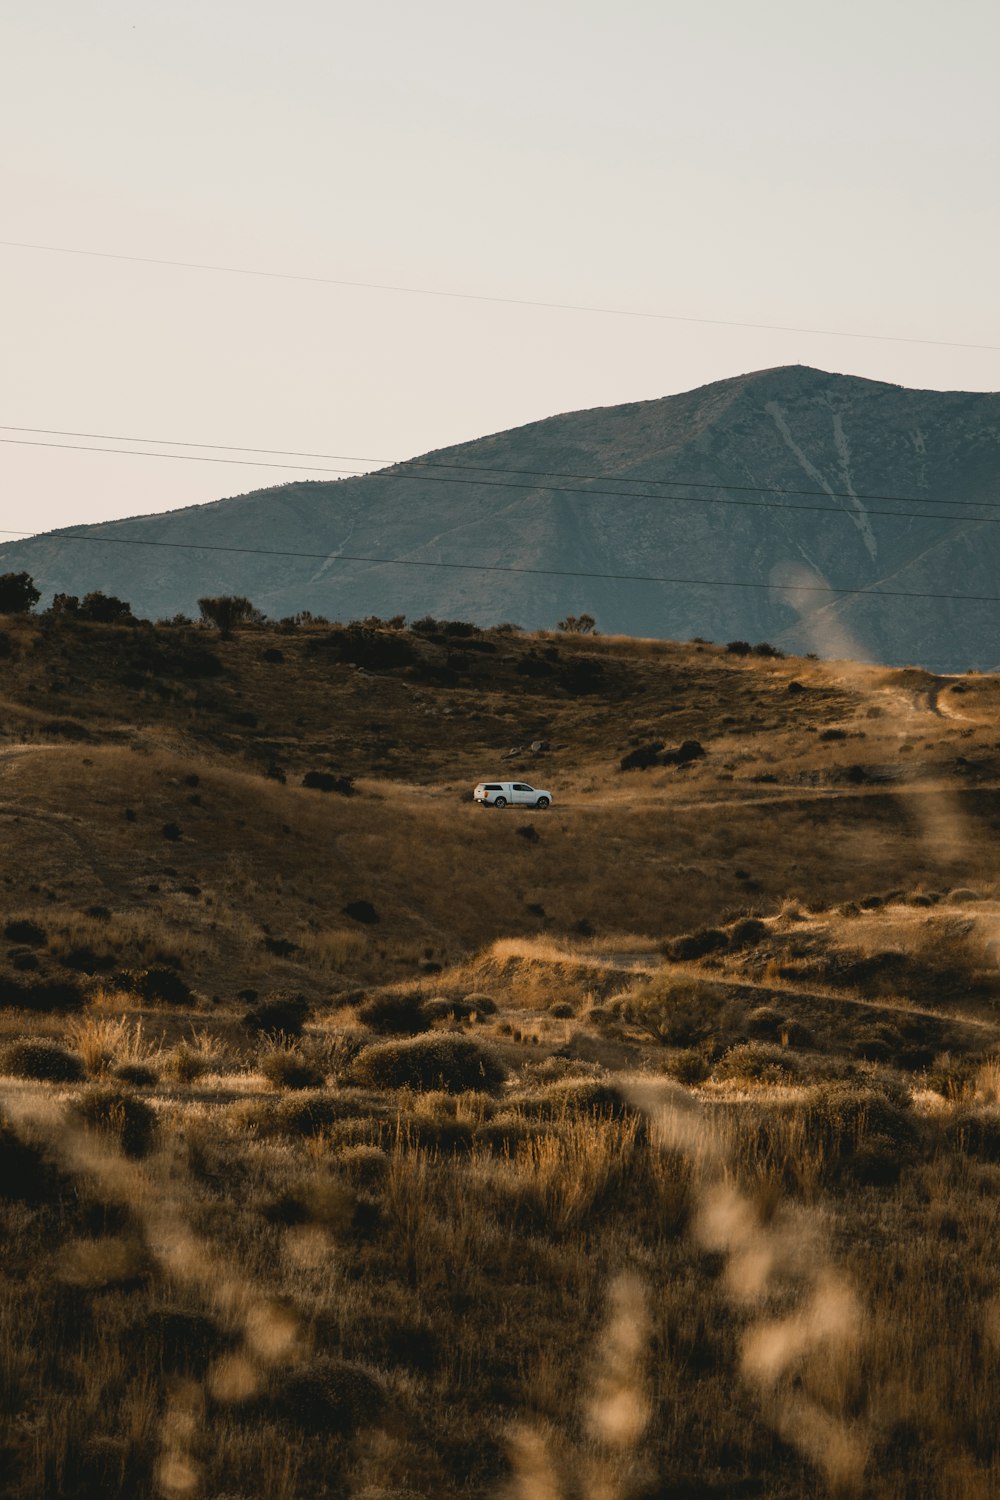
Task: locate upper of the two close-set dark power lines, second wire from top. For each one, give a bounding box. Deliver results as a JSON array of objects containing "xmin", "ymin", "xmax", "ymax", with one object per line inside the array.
[{"xmin": 0, "ymin": 422, "xmax": 1000, "ymax": 519}]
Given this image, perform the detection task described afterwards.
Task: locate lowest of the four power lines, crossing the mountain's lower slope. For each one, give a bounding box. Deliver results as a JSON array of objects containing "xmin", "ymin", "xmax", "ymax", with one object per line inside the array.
[{"xmin": 0, "ymin": 528, "xmax": 1000, "ymax": 605}]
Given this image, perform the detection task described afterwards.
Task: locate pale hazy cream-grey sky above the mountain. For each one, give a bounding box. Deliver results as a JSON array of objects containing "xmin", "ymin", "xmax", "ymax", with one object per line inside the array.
[{"xmin": 0, "ymin": 0, "xmax": 1000, "ymax": 530}]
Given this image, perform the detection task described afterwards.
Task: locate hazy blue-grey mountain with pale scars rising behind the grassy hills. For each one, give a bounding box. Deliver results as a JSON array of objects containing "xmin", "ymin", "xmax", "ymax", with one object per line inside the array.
[{"xmin": 0, "ymin": 366, "xmax": 1000, "ymax": 671}]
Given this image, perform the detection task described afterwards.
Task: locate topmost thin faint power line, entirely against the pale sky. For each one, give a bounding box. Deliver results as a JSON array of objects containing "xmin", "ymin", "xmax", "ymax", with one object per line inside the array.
[{"xmin": 0, "ymin": 240, "xmax": 1000, "ymax": 353}]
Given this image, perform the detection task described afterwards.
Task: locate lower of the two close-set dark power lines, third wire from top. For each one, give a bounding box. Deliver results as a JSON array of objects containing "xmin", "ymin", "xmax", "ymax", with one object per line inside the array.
[{"xmin": 0, "ymin": 438, "xmax": 1000, "ymax": 525}]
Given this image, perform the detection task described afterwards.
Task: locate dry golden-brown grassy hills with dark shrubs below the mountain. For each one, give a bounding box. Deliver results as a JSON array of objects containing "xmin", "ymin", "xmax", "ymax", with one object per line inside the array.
[{"xmin": 0, "ymin": 617, "xmax": 1000, "ymax": 1500}]
